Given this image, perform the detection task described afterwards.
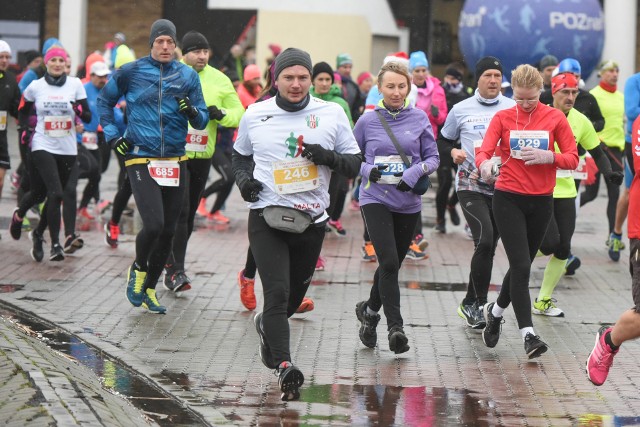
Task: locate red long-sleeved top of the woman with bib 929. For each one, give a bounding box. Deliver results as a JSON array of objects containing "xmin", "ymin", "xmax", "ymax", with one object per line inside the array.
[{"xmin": 476, "ymin": 102, "xmax": 578, "ymax": 196}]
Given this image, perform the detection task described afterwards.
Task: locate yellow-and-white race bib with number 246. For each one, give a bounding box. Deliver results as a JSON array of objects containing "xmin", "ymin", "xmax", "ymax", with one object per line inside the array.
[{"xmin": 272, "ymin": 157, "xmax": 320, "ymax": 194}]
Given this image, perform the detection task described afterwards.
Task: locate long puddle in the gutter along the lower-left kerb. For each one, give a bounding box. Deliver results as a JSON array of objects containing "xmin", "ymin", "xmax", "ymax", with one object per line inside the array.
[{"xmin": 0, "ymin": 307, "xmax": 206, "ymax": 426}]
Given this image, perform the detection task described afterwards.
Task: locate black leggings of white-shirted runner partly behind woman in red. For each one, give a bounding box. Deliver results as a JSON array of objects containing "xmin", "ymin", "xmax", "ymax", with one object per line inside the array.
[{"xmin": 457, "ymin": 190, "xmax": 500, "ymax": 305}]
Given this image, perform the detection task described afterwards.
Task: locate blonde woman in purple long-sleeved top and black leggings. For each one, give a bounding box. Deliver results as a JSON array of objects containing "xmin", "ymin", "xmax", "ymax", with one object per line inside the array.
[{"xmin": 353, "ymin": 62, "xmax": 440, "ymax": 354}]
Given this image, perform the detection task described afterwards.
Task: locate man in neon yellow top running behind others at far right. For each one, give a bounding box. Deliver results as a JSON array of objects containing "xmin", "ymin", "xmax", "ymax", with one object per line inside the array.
[{"xmin": 580, "ymin": 60, "xmax": 625, "ymax": 261}]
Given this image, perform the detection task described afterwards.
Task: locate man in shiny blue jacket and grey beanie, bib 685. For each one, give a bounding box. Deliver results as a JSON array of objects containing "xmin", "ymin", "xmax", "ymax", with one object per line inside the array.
[{"xmin": 98, "ymin": 19, "xmax": 209, "ymax": 313}]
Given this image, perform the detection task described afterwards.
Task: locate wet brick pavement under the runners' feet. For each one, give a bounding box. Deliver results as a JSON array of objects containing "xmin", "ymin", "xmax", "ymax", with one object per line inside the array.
[{"xmin": 0, "ymin": 122, "xmax": 640, "ymax": 426}]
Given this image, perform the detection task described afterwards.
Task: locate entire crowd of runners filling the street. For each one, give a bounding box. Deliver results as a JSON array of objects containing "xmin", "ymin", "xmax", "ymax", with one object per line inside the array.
[{"xmin": 0, "ymin": 19, "xmax": 640, "ymax": 400}]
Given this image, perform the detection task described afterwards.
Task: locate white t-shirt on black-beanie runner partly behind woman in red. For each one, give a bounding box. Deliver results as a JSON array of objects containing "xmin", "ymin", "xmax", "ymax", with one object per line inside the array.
[{"xmin": 440, "ymin": 94, "xmax": 516, "ymax": 195}]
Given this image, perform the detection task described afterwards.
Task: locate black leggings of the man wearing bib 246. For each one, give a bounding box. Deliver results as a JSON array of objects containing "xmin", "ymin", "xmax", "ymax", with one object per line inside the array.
[{"xmin": 248, "ymin": 209, "xmax": 325, "ymax": 365}]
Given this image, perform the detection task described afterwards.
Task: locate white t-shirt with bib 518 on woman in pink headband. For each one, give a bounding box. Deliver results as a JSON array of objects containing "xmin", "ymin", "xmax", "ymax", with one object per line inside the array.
[{"xmin": 24, "ymin": 76, "xmax": 87, "ymax": 155}]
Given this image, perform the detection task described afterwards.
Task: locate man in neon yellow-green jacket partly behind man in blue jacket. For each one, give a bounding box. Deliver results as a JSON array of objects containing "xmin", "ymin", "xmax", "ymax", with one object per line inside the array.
[{"xmin": 164, "ymin": 31, "xmax": 244, "ymax": 293}]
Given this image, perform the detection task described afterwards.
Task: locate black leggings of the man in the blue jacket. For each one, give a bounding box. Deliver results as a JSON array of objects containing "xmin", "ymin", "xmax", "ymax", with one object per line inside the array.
[{"xmin": 127, "ymin": 162, "xmax": 186, "ymax": 289}]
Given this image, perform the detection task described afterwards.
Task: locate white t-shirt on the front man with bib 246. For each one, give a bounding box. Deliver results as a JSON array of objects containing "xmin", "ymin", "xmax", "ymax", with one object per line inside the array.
[{"xmin": 234, "ymin": 97, "xmax": 360, "ymax": 217}]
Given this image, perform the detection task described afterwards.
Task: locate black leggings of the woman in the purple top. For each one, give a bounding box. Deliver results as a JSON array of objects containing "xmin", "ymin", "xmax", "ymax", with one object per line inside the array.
[{"xmin": 361, "ymin": 203, "xmax": 420, "ymax": 329}]
